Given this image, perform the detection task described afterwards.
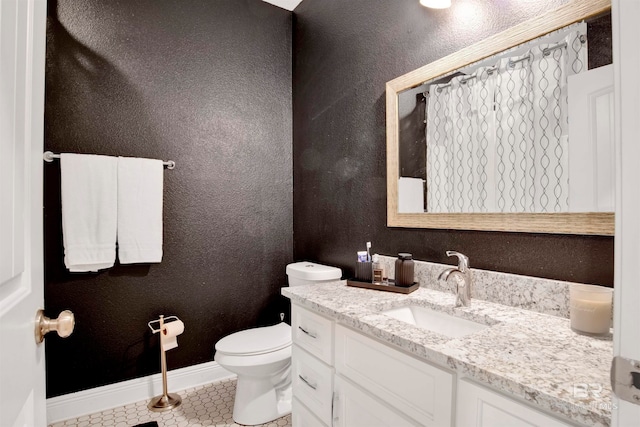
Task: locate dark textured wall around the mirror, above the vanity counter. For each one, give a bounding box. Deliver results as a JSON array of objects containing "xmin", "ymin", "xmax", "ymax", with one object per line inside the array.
[{"xmin": 293, "ymin": 0, "xmax": 613, "ymax": 285}]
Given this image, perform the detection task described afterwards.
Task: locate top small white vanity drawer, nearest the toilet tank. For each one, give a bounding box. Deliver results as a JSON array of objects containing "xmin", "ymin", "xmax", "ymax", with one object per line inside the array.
[{"xmin": 291, "ymin": 305, "xmax": 333, "ymax": 365}]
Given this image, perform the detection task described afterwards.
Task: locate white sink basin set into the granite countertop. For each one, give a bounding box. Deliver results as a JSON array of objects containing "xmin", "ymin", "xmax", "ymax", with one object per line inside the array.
[{"xmin": 382, "ymin": 305, "xmax": 488, "ymax": 338}]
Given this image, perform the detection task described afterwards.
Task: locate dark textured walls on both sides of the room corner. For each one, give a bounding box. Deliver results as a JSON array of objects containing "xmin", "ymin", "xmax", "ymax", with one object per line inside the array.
[{"xmin": 45, "ymin": 0, "xmax": 613, "ymax": 397}]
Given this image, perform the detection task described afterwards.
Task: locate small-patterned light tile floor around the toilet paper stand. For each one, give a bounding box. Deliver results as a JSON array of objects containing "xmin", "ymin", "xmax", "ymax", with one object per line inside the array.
[{"xmin": 50, "ymin": 379, "xmax": 291, "ymax": 427}]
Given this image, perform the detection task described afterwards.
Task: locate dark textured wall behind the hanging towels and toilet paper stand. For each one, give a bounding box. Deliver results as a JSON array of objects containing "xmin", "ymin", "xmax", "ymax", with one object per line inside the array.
[{"xmin": 44, "ymin": 0, "xmax": 293, "ymax": 397}]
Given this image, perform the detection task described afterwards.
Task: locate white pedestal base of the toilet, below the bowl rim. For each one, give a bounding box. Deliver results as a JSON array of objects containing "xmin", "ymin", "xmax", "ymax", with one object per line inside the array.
[{"xmin": 233, "ymin": 375, "xmax": 292, "ymax": 426}]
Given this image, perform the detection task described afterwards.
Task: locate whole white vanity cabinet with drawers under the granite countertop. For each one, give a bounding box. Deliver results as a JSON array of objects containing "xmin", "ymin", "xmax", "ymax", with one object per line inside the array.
[{"xmin": 291, "ymin": 304, "xmax": 571, "ymax": 427}]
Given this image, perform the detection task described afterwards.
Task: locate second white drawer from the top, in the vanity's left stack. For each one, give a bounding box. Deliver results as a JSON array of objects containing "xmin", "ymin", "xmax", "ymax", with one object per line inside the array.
[{"xmin": 291, "ymin": 344, "xmax": 333, "ymax": 425}]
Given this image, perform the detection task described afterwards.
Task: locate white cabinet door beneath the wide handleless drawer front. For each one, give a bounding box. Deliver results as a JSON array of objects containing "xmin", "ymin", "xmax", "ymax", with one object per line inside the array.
[{"xmin": 332, "ymin": 375, "xmax": 420, "ymax": 427}]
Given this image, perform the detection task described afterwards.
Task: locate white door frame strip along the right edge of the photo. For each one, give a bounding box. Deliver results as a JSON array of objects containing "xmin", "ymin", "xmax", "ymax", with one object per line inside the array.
[{"xmin": 611, "ymin": 0, "xmax": 640, "ymax": 427}]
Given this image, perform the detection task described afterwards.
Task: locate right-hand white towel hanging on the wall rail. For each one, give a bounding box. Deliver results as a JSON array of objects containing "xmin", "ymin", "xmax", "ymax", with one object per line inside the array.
[{"xmin": 118, "ymin": 157, "xmax": 164, "ymax": 264}]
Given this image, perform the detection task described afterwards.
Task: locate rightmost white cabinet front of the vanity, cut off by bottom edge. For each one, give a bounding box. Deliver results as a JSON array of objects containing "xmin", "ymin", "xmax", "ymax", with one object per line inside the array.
[{"xmin": 456, "ymin": 380, "xmax": 570, "ymax": 427}]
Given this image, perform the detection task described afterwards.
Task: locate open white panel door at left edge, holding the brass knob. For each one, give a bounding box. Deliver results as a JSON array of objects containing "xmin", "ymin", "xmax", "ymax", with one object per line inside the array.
[{"xmin": 0, "ymin": 0, "xmax": 46, "ymax": 427}]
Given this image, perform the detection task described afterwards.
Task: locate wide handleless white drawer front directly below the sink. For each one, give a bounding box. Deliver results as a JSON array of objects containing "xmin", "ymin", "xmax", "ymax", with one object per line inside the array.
[{"xmin": 335, "ymin": 325, "xmax": 454, "ymax": 426}]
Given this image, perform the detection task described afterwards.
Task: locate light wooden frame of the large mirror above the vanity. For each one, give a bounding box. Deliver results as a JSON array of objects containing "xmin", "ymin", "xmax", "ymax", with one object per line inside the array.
[{"xmin": 386, "ymin": 0, "xmax": 614, "ymax": 235}]
